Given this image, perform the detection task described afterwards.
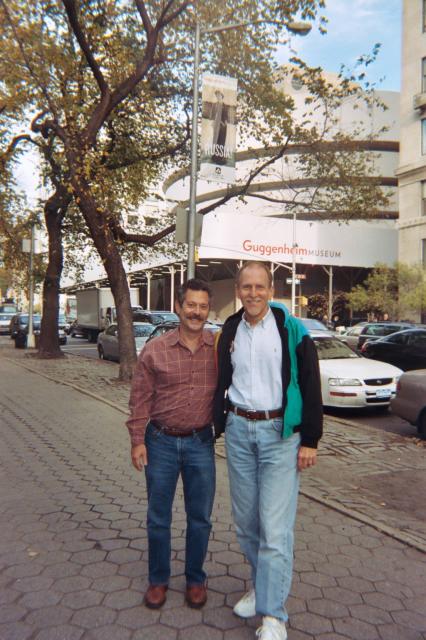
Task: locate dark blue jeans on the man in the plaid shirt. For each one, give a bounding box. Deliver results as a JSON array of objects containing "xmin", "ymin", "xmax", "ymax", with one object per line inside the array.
[{"xmin": 145, "ymin": 424, "xmax": 216, "ymax": 584}]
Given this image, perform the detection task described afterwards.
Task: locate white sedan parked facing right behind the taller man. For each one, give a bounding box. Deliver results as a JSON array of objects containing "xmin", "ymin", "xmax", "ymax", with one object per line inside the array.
[{"xmin": 311, "ymin": 332, "xmax": 402, "ymax": 408}]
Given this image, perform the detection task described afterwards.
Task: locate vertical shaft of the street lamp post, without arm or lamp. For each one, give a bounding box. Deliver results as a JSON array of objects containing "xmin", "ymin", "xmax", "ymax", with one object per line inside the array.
[{"xmin": 187, "ymin": 22, "xmax": 200, "ymax": 280}]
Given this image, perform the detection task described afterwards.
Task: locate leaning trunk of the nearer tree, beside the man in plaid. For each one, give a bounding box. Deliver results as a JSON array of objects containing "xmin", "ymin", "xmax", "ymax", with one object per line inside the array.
[{"xmin": 70, "ymin": 171, "xmax": 136, "ymax": 381}]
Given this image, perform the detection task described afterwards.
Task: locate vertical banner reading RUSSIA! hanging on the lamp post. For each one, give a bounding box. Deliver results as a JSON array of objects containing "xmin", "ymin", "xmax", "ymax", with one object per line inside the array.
[{"xmin": 200, "ymin": 75, "xmax": 237, "ymax": 184}]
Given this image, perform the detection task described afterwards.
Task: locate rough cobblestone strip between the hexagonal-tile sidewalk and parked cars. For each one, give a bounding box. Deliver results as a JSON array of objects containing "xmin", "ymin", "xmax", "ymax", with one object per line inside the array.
[{"xmin": 4, "ymin": 339, "xmax": 426, "ymax": 551}]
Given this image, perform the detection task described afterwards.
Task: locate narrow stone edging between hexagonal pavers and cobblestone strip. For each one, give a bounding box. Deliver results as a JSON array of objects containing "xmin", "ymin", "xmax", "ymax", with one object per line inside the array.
[{"xmin": 4, "ymin": 356, "xmax": 426, "ymax": 553}]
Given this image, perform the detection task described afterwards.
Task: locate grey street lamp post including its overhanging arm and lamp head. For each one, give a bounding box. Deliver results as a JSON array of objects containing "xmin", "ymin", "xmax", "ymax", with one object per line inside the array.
[{"xmin": 187, "ymin": 20, "xmax": 312, "ymax": 279}]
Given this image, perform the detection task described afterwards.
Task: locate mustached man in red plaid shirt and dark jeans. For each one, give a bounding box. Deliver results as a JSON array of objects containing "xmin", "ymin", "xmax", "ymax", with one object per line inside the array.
[{"xmin": 126, "ymin": 279, "xmax": 216, "ymax": 609}]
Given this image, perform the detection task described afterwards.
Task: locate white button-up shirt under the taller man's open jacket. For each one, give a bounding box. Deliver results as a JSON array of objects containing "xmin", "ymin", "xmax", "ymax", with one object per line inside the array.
[{"xmin": 228, "ymin": 309, "xmax": 283, "ymax": 411}]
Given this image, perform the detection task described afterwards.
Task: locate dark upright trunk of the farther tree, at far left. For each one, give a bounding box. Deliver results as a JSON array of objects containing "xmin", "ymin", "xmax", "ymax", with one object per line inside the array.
[{"xmin": 38, "ymin": 186, "xmax": 71, "ymax": 358}]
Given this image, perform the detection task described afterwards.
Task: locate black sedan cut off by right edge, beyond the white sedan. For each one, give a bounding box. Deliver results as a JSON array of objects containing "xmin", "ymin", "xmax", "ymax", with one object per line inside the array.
[{"xmin": 361, "ymin": 329, "xmax": 426, "ymax": 371}]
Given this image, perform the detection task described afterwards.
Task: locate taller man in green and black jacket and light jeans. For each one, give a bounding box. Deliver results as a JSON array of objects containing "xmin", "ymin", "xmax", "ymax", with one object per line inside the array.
[{"xmin": 214, "ymin": 262, "xmax": 322, "ymax": 640}]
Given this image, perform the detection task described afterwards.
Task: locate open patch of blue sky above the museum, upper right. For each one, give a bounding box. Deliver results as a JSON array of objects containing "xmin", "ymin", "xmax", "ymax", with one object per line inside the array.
[{"xmin": 278, "ymin": 0, "xmax": 402, "ymax": 91}]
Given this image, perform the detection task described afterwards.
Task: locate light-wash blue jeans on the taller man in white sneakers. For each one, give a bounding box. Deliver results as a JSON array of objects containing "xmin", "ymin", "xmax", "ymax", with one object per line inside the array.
[{"xmin": 225, "ymin": 412, "xmax": 300, "ymax": 621}]
